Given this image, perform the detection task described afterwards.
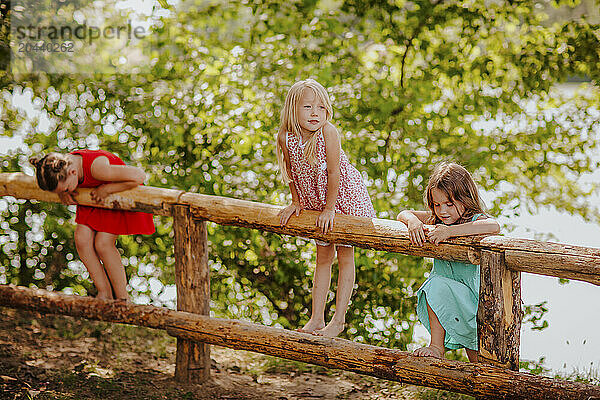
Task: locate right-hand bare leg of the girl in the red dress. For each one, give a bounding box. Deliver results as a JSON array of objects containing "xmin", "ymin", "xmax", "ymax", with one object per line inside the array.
[{"xmin": 94, "ymin": 232, "xmax": 129, "ymax": 300}]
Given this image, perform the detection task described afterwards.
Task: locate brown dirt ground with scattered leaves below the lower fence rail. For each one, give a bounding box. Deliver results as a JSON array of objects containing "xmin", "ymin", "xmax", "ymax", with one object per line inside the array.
[{"xmin": 0, "ymin": 307, "xmax": 468, "ymax": 400}]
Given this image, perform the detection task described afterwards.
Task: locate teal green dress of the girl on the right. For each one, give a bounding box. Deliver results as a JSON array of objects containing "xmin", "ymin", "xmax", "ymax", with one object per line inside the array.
[{"xmin": 416, "ymin": 214, "xmax": 482, "ymax": 350}]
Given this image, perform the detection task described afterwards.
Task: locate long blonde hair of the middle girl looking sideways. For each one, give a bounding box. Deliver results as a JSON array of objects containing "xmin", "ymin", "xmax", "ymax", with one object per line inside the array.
[{"xmin": 277, "ymin": 79, "xmax": 333, "ymax": 184}]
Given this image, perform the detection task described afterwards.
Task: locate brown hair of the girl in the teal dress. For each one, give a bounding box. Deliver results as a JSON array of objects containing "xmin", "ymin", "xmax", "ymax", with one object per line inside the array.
[{"xmin": 424, "ymin": 162, "xmax": 485, "ymax": 225}]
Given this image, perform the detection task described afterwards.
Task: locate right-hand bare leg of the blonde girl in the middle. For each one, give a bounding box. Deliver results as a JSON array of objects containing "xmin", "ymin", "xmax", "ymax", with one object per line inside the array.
[{"xmin": 315, "ymin": 246, "xmax": 356, "ymax": 337}]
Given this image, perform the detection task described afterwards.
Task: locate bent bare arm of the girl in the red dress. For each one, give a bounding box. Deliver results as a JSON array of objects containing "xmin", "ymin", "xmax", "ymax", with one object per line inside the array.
[{"xmin": 90, "ymin": 156, "xmax": 146, "ymax": 202}]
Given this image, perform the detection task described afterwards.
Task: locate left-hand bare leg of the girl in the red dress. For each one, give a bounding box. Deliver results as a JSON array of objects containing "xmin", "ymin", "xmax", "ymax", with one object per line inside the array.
[{"xmin": 75, "ymin": 224, "xmax": 113, "ymax": 299}]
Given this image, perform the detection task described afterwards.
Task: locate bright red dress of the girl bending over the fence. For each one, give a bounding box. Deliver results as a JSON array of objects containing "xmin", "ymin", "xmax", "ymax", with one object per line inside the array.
[{"xmin": 71, "ymin": 150, "xmax": 155, "ymax": 235}]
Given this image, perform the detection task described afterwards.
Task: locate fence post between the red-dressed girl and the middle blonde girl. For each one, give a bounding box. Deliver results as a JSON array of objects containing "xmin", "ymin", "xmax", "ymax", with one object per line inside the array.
[{"xmin": 173, "ymin": 205, "xmax": 210, "ymax": 383}]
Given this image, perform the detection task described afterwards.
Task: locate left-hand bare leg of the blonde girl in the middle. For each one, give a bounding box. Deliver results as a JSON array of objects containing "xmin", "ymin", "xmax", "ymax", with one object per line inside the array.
[{"xmin": 298, "ymin": 244, "xmax": 335, "ymax": 333}]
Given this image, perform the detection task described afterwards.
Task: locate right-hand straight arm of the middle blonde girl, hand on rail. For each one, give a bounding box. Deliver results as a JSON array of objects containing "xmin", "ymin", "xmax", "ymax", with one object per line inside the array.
[{"xmin": 317, "ymin": 122, "xmax": 341, "ymax": 233}]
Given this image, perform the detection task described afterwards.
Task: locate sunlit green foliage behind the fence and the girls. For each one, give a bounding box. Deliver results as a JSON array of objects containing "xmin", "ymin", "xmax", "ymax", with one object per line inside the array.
[{"xmin": 0, "ymin": 0, "xmax": 600, "ymax": 349}]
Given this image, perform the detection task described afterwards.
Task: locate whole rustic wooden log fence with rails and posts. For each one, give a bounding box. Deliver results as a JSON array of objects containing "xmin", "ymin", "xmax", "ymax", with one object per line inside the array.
[{"xmin": 0, "ymin": 173, "xmax": 600, "ymax": 399}]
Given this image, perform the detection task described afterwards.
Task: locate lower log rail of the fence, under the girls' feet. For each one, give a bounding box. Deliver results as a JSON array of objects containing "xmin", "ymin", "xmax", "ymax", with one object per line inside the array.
[{"xmin": 0, "ymin": 285, "xmax": 600, "ymax": 400}]
